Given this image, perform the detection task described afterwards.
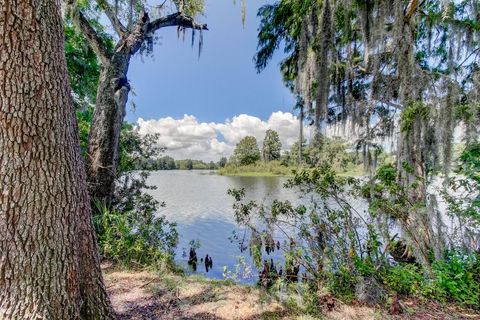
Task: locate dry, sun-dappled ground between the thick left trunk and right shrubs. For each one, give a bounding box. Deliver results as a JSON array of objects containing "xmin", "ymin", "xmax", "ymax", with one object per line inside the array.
[{"xmin": 105, "ymin": 271, "xmax": 284, "ymax": 320}]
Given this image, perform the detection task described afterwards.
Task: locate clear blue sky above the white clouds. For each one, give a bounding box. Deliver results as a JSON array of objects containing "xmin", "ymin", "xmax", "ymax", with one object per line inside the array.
[{"xmin": 127, "ymin": 0, "xmax": 293, "ymax": 122}]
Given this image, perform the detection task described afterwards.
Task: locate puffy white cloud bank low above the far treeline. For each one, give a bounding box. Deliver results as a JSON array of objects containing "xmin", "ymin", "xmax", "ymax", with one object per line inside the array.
[{"xmin": 137, "ymin": 111, "xmax": 306, "ymax": 161}]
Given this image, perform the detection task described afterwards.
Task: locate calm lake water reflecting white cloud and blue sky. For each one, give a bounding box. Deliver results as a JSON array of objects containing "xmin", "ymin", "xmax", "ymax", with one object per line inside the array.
[{"xmin": 148, "ymin": 170, "xmax": 298, "ymax": 282}]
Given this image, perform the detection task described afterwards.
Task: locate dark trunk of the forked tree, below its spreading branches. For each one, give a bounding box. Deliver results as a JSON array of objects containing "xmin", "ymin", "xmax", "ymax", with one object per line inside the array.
[{"xmin": 87, "ymin": 52, "xmax": 130, "ymax": 204}]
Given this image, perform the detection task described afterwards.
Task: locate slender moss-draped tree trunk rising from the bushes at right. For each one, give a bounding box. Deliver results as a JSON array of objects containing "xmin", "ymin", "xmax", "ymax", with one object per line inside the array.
[{"xmin": 395, "ymin": 8, "xmax": 434, "ymax": 268}]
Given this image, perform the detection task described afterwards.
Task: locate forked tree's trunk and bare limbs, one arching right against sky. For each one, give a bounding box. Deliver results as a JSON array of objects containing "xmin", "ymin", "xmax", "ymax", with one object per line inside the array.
[{"xmin": 80, "ymin": 11, "xmax": 208, "ymax": 205}]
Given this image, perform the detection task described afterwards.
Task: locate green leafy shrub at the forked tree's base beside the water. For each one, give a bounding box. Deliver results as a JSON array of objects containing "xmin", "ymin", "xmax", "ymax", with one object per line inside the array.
[{"xmin": 94, "ymin": 124, "xmax": 178, "ymax": 269}]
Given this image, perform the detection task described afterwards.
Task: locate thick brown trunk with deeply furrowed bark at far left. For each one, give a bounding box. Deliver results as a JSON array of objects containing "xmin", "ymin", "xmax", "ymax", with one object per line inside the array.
[{"xmin": 0, "ymin": 0, "xmax": 112, "ymax": 320}]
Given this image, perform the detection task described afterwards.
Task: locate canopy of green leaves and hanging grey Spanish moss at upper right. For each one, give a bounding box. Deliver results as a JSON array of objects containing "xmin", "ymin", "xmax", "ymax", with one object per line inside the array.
[{"xmin": 255, "ymin": 0, "xmax": 480, "ymax": 190}]
